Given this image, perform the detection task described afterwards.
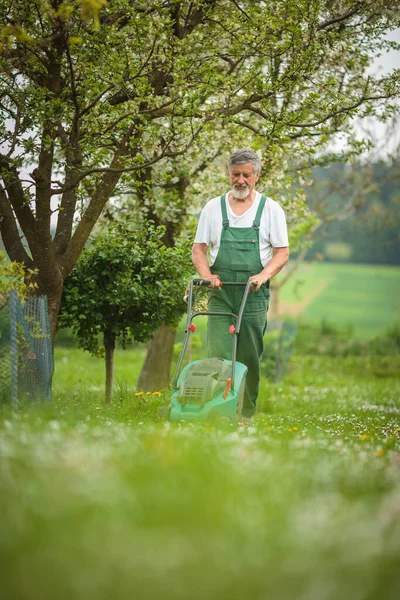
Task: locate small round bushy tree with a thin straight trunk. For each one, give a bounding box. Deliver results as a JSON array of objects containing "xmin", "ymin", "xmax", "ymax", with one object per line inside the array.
[{"xmin": 59, "ymin": 222, "xmax": 190, "ymax": 402}]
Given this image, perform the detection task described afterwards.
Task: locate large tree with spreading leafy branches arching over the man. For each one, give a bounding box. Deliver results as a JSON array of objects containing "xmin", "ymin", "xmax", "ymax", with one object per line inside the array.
[{"xmin": 0, "ymin": 0, "xmax": 399, "ymax": 344}]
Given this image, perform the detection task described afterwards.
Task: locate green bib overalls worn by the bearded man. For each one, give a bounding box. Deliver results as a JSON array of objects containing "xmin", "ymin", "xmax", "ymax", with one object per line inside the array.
[{"xmin": 207, "ymin": 195, "xmax": 269, "ymax": 416}]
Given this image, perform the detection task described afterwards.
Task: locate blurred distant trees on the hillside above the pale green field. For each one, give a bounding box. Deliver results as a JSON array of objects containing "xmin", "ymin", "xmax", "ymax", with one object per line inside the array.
[{"xmin": 307, "ymin": 157, "xmax": 400, "ymax": 265}]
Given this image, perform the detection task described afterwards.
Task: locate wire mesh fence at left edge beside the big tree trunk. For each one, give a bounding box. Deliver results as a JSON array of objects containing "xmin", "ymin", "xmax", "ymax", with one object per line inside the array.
[{"xmin": 0, "ymin": 292, "xmax": 54, "ymax": 404}]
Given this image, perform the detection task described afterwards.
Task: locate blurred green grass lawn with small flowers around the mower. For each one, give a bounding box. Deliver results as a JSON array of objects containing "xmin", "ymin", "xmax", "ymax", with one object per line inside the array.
[{"xmin": 0, "ymin": 349, "xmax": 400, "ymax": 600}]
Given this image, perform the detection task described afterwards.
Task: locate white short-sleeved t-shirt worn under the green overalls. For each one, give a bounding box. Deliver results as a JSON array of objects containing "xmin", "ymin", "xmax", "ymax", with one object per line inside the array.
[{"xmin": 194, "ymin": 192, "xmax": 289, "ymax": 267}]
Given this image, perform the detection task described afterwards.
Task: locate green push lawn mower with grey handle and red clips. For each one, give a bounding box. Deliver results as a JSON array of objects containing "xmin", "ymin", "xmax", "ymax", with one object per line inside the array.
[{"xmin": 169, "ymin": 279, "xmax": 254, "ymax": 421}]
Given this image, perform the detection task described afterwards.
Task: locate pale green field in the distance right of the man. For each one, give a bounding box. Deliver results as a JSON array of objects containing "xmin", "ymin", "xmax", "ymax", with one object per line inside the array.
[{"xmin": 281, "ymin": 262, "xmax": 400, "ymax": 339}]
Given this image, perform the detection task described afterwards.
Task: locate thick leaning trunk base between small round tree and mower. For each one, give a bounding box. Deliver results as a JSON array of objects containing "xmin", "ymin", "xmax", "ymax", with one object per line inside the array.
[{"xmin": 137, "ymin": 325, "xmax": 176, "ymax": 392}]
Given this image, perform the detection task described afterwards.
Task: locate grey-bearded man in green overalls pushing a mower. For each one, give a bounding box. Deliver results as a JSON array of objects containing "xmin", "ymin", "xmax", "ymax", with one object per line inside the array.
[{"xmin": 192, "ymin": 150, "xmax": 289, "ymax": 417}]
